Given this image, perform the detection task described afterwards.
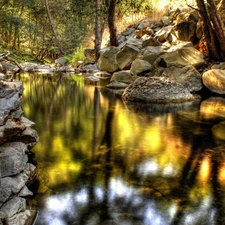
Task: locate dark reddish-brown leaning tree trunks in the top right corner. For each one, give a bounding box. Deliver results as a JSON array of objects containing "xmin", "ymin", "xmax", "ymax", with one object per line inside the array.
[{"xmin": 196, "ymin": 0, "xmax": 225, "ymax": 60}]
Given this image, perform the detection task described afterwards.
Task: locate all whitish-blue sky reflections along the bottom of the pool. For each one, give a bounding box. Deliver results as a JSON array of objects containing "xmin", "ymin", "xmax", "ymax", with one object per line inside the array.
[{"xmin": 39, "ymin": 178, "xmax": 218, "ymax": 225}]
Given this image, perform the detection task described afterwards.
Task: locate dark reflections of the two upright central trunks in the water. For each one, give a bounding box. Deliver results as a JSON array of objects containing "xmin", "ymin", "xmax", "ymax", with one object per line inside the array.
[{"xmin": 79, "ymin": 87, "xmax": 114, "ymax": 225}]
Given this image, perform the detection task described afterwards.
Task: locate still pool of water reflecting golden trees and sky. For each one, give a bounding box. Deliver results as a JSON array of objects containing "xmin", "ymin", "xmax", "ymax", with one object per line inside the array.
[{"xmin": 20, "ymin": 74, "xmax": 225, "ymax": 225}]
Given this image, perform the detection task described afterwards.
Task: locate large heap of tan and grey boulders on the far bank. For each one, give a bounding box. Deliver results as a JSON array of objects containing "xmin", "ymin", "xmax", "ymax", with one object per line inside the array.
[{"xmin": 96, "ymin": 7, "xmax": 225, "ymax": 102}]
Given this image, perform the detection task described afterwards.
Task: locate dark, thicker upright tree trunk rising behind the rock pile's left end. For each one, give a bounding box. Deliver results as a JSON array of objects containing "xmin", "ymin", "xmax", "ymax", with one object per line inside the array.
[{"xmin": 108, "ymin": 0, "xmax": 119, "ymax": 46}]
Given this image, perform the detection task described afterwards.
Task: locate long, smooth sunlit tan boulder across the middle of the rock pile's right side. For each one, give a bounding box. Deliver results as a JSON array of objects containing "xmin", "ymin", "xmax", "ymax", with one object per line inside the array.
[{"xmin": 153, "ymin": 47, "xmax": 205, "ymax": 68}]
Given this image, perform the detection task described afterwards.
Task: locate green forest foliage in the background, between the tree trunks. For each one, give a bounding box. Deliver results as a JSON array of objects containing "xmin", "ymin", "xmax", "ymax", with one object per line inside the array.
[{"xmin": 0, "ymin": 0, "xmax": 165, "ymax": 61}]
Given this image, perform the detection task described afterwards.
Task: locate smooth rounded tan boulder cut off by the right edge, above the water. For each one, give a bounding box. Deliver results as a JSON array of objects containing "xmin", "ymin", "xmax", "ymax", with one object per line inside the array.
[{"xmin": 202, "ymin": 69, "xmax": 225, "ymax": 95}]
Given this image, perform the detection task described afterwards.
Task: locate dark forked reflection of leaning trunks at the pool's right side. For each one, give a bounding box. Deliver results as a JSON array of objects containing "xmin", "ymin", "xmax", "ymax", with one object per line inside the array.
[{"xmin": 171, "ymin": 118, "xmax": 225, "ymax": 225}]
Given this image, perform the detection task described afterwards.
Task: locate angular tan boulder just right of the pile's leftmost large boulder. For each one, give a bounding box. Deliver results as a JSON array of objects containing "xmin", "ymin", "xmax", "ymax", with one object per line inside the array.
[{"xmin": 116, "ymin": 45, "xmax": 139, "ymax": 70}]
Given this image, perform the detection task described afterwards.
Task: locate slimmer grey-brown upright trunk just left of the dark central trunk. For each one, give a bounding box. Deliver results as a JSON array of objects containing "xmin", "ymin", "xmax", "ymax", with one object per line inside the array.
[{"xmin": 95, "ymin": 0, "xmax": 102, "ymax": 62}]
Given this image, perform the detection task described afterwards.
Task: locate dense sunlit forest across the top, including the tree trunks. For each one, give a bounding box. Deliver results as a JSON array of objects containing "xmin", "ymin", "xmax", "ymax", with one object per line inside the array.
[{"xmin": 0, "ymin": 0, "xmax": 225, "ymax": 61}]
